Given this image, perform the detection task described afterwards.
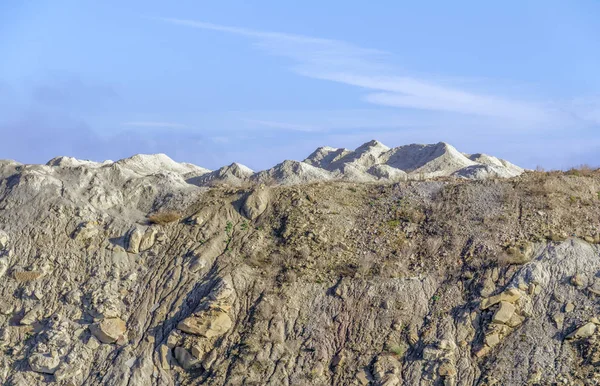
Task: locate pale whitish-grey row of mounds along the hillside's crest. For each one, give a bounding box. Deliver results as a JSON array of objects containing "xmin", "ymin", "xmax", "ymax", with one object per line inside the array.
[{"xmin": 0, "ymin": 140, "xmax": 524, "ymax": 191}]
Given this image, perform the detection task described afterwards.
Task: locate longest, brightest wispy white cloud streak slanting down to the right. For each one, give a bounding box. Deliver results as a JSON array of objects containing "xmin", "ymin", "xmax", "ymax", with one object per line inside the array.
[{"xmin": 158, "ymin": 18, "xmax": 567, "ymax": 127}]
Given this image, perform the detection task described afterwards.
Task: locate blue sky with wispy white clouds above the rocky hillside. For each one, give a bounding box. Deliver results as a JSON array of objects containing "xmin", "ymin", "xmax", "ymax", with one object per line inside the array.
[{"xmin": 0, "ymin": 0, "xmax": 600, "ymax": 169}]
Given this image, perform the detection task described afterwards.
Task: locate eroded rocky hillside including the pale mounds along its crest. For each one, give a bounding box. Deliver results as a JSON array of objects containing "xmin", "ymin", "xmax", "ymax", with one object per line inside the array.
[{"xmin": 0, "ymin": 150, "xmax": 600, "ymax": 386}]
